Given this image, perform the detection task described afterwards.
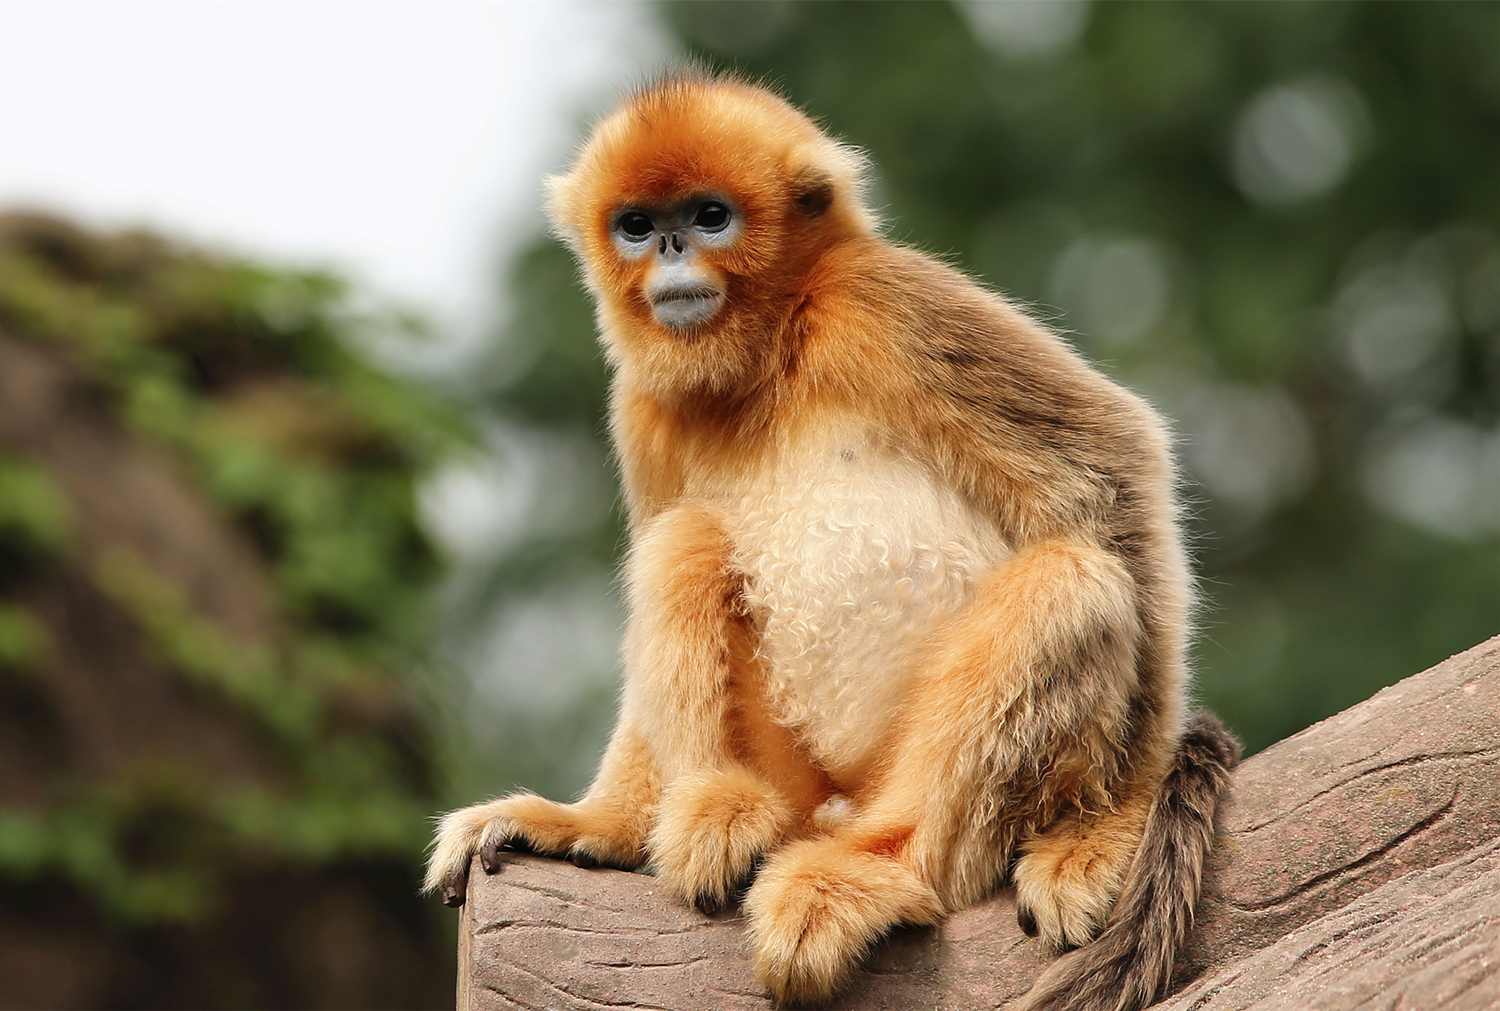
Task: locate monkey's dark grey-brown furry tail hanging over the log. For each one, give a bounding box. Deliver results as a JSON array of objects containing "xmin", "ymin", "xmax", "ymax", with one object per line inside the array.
[{"xmin": 1016, "ymin": 713, "xmax": 1239, "ymax": 1011}]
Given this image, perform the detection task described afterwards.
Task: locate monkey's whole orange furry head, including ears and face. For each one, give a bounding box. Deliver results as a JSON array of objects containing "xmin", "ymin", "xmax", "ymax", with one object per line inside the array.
[{"xmin": 548, "ymin": 74, "xmax": 875, "ymax": 395}]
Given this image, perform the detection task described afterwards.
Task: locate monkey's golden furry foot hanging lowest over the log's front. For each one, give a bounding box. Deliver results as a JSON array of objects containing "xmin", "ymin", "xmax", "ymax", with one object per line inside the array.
[{"xmin": 746, "ymin": 839, "xmax": 942, "ymax": 1007}]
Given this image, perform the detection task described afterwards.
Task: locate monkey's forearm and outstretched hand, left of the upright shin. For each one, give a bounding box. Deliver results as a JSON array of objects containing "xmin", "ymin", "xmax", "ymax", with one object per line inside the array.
[{"xmin": 426, "ymin": 716, "xmax": 660, "ymax": 906}]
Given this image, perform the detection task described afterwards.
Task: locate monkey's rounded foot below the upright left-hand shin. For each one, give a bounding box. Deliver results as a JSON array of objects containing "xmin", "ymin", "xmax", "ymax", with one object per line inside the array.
[{"xmin": 650, "ymin": 768, "xmax": 797, "ymax": 912}]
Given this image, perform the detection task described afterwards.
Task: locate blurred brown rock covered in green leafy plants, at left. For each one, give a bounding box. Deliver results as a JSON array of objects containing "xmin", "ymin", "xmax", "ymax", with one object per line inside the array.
[{"xmin": 0, "ymin": 215, "xmax": 467, "ymax": 1007}]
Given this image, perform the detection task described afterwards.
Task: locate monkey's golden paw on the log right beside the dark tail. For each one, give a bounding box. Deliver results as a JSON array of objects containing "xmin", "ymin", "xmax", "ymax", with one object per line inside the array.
[{"xmin": 1013, "ymin": 806, "xmax": 1145, "ymax": 950}]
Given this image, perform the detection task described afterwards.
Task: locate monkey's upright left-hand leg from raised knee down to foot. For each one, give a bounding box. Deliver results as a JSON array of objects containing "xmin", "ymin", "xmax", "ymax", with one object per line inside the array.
[{"xmin": 626, "ymin": 507, "xmax": 798, "ymax": 909}]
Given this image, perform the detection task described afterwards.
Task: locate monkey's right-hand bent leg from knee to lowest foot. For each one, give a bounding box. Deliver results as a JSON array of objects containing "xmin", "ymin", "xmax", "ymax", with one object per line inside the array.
[{"xmin": 746, "ymin": 542, "xmax": 1140, "ymax": 1002}]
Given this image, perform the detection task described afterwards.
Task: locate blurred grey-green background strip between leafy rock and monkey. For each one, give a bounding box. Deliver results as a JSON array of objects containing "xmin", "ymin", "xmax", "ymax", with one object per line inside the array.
[{"xmin": 444, "ymin": 232, "xmax": 624, "ymax": 803}]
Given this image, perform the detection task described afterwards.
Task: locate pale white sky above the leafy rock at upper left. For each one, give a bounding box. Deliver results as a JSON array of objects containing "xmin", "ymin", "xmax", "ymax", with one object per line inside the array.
[{"xmin": 0, "ymin": 0, "xmax": 665, "ymax": 340}]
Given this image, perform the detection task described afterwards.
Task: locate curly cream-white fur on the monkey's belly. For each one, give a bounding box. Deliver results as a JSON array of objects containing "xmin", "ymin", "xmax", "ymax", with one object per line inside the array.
[{"xmin": 729, "ymin": 434, "xmax": 1010, "ymax": 774}]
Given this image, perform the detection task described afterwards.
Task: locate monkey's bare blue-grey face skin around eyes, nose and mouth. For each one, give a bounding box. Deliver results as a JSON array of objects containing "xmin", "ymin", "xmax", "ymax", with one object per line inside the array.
[{"xmin": 609, "ymin": 194, "xmax": 744, "ymax": 330}]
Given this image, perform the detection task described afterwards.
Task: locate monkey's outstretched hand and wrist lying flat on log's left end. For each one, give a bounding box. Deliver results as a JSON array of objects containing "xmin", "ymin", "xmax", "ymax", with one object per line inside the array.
[{"xmin": 423, "ymin": 794, "xmax": 644, "ymax": 906}]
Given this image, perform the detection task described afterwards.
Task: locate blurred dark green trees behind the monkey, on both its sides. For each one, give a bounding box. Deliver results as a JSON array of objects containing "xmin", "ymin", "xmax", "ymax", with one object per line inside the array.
[{"xmin": 456, "ymin": 0, "xmax": 1500, "ymax": 794}]
